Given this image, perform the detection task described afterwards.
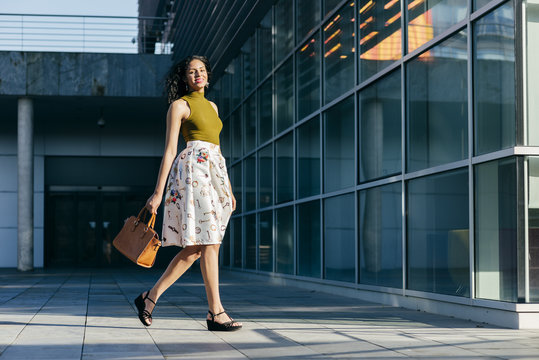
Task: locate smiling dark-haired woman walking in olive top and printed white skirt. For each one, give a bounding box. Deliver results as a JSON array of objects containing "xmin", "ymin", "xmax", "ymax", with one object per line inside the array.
[{"xmin": 135, "ymin": 55, "xmax": 242, "ymax": 331}]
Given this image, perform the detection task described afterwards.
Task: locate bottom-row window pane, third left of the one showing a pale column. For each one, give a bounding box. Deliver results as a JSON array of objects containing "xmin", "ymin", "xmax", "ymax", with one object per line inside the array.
[{"xmin": 276, "ymin": 206, "xmax": 294, "ymax": 274}]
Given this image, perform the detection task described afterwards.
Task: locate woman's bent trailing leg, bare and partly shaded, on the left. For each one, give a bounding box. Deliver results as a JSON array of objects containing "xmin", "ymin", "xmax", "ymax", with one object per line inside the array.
[{"xmin": 142, "ymin": 245, "xmax": 202, "ymax": 312}]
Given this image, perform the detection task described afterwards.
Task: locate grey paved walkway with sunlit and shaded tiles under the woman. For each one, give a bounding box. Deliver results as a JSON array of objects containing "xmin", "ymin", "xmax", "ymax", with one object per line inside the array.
[{"xmin": 0, "ymin": 269, "xmax": 539, "ymax": 360}]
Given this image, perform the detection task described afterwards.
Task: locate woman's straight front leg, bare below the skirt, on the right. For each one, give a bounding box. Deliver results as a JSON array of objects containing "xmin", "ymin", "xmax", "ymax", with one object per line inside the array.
[{"xmin": 200, "ymin": 244, "xmax": 241, "ymax": 325}]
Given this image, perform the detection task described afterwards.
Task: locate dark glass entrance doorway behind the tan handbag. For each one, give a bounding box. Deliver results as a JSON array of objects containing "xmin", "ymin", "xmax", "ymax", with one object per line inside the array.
[{"xmin": 45, "ymin": 187, "xmax": 154, "ymax": 267}]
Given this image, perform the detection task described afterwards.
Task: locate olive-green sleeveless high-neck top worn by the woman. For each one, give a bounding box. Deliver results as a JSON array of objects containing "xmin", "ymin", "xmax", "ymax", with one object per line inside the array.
[{"xmin": 181, "ymin": 91, "xmax": 223, "ymax": 145}]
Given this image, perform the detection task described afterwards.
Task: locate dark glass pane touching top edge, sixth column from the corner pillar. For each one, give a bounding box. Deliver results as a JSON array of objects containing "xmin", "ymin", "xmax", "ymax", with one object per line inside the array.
[{"xmin": 275, "ymin": 0, "xmax": 294, "ymax": 64}]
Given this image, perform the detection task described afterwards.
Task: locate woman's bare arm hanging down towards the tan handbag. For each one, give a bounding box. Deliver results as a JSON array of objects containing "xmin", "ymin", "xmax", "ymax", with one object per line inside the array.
[{"xmin": 146, "ymin": 100, "xmax": 189, "ymax": 213}]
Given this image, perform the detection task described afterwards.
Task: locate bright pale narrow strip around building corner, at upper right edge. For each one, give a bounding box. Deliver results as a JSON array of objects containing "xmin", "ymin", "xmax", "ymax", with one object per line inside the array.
[{"xmin": 525, "ymin": 1, "xmax": 539, "ymax": 146}]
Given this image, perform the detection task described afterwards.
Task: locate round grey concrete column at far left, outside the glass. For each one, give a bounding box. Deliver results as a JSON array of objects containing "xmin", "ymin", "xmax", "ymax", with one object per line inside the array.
[{"xmin": 17, "ymin": 98, "xmax": 34, "ymax": 271}]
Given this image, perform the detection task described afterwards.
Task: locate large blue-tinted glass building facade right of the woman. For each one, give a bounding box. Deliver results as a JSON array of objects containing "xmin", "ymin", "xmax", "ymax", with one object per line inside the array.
[{"xmin": 212, "ymin": 0, "xmax": 539, "ymax": 303}]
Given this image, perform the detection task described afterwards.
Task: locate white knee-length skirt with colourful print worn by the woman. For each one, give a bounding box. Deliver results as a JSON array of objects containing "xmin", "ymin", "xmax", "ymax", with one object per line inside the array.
[{"xmin": 162, "ymin": 140, "xmax": 232, "ymax": 247}]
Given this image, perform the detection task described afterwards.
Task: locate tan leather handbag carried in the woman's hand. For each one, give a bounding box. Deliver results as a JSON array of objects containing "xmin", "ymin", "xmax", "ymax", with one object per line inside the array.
[{"xmin": 112, "ymin": 207, "xmax": 161, "ymax": 268}]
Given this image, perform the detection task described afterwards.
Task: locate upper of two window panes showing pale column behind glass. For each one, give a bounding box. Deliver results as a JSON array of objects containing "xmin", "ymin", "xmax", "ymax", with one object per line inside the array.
[{"xmin": 359, "ymin": 70, "xmax": 402, "ymax": 181}]
